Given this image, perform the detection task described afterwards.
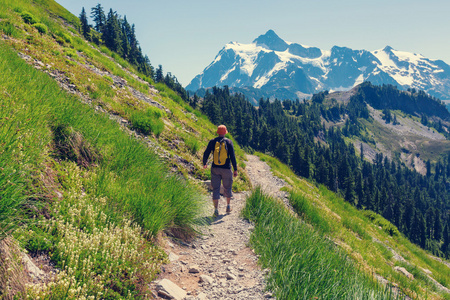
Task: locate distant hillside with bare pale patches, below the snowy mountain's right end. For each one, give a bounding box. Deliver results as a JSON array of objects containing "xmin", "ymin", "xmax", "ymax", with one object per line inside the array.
[{"xmin": 313, "ymin": 82, "xmax": 450, "ymax": 175}]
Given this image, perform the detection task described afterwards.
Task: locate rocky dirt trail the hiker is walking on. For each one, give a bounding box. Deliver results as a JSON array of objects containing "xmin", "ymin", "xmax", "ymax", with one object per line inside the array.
[{"xmin": 153, "ymin": 155, "xmax": 286, "ymax": 300}]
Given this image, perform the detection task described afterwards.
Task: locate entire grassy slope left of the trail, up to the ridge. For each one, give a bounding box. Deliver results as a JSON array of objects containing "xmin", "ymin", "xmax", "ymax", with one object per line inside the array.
[{"xmin": 0, "ymin": 0, "xmax": 248, "ymax": 299}]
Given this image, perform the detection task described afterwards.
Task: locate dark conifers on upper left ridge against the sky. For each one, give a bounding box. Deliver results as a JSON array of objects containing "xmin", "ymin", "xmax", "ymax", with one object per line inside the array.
[{"xmin": 79, "ymin": 3, "xmax": 189, "ymax": 101}]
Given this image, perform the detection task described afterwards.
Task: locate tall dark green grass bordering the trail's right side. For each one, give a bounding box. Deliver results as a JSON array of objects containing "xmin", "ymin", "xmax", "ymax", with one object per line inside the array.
[{"xmin": 243, "ymin": 188, "xmax": 393, "ymax": 299}]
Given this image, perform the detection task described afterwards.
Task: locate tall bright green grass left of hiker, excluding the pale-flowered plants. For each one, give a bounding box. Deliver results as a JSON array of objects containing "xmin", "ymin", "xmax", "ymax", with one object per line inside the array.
[{"xmin": 0, "ymin": 39, "xmax": 201, "ymax": 236}]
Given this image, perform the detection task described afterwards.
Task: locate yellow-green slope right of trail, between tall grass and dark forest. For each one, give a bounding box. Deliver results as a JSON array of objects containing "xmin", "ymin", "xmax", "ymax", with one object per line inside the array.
[{"xmin": 255, "ymin": 154, "xmax": 450, "ymax": 299}]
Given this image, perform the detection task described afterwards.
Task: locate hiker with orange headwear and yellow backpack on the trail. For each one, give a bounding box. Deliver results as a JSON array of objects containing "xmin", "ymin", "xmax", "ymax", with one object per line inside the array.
[{"xmin": 203, "ymin": 125, "xmax": 237, "ymax": 217}]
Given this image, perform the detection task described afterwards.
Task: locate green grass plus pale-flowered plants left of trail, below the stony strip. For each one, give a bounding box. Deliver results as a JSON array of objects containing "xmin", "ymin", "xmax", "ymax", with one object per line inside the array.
[{"xmin": 0, "ymin": 43, "xmax": 204, "ymax": 299}]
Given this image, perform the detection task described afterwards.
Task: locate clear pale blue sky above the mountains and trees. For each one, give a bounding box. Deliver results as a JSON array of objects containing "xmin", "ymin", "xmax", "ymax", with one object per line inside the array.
[{"xmin": 56, "ymin": 0, "xmax": 450, "ymax": 86}]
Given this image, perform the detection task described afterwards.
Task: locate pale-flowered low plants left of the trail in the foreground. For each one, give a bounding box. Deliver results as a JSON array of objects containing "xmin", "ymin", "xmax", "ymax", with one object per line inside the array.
[{"xmin": 16, "ymin": 162, "xmax": 165, "ymax": 299}]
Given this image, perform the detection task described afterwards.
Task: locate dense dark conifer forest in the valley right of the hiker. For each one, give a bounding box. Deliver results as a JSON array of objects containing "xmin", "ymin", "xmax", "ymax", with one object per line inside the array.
[{"xmin": 200, "ymin": 86, "xmax": 450, "ymax": 257}]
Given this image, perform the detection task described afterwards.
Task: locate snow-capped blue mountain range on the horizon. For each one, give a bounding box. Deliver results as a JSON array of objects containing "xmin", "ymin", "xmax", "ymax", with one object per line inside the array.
[{"xmin": 186, "ymin": 30, "xmax": 450, "ymax": 99}]
